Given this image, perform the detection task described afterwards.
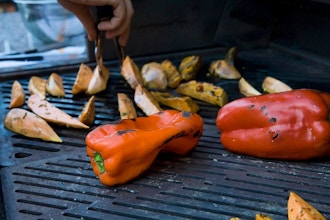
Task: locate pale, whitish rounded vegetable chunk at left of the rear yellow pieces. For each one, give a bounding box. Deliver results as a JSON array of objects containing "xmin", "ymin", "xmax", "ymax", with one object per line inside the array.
[{"xmin": 141, "ymin": 62, "xmax": 167, "ymax": 89}]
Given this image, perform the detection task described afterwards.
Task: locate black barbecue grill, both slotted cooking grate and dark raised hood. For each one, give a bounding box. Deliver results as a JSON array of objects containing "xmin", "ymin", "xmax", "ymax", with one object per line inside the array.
[{"xmin": 0, "ymin": 0, "xmax": 330, "ymax": 220}]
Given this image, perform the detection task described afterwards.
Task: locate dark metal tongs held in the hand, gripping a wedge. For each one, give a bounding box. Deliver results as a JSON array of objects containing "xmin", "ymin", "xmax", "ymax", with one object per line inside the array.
[{"xmin": 95, "ymin": 5, "xmax": 125, "ymax": 71}]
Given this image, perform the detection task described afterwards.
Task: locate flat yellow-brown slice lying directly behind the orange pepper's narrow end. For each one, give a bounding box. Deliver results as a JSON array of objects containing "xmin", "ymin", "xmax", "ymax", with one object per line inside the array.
[{"xmin": 151, "ymin": 91, "xmax": 199, "ymax": 113}]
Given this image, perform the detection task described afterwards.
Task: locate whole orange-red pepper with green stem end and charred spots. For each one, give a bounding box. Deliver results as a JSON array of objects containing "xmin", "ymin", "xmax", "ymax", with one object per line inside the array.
[{"xmin": 86, "ymin": 110, "xmax": 204, "ymax": 186}]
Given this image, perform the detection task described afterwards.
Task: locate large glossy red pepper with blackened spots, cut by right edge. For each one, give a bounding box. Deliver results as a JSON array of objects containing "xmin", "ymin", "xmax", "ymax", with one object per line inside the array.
[{"xmin": 216, "ymin": 89, "xmax": 330, "ymax": 160}]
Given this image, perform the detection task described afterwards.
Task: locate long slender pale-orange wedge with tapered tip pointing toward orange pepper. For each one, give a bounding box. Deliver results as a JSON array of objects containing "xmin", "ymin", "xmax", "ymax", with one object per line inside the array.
[{"xmin": 28, "ymin": 95, "xmax": 89, "ymax": 128}]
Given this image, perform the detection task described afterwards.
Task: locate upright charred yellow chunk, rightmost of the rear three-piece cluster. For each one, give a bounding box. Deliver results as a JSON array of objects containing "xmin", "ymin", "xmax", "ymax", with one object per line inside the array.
[{"xmin": 179, "ymin": 55, "xmax": 202, "ymax": 81}]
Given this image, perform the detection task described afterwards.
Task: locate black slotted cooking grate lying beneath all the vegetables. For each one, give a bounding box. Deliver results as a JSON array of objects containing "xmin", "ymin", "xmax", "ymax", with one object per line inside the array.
[{"xmin": 0, "ymin": 47, "xmax": 330, "ymax": 219}]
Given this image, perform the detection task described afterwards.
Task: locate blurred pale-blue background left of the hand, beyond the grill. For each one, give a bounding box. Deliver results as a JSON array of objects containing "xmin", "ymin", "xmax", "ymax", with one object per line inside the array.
[{"xmin": 0, "ymin": 0, "xmax": 87, "ymax": 73}]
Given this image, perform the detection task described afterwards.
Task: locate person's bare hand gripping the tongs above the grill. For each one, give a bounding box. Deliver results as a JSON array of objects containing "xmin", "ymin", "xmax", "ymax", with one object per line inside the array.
[{"xmin": 58, "ymin": 0, "xmax": 134, "ymax": 46}]
